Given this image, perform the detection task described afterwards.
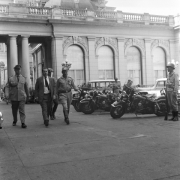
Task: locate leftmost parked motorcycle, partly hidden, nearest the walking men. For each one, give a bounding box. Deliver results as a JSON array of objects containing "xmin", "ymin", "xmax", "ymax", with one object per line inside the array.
[{"xmin": 71, "ymin": 88, "xmax": 90, "ymax": 112}]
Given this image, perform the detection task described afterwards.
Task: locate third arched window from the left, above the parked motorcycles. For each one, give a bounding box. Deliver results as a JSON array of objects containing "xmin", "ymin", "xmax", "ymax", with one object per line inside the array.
[{"xmin": 126, "ymin": 47, "xmax": 142, "ymax": 85}]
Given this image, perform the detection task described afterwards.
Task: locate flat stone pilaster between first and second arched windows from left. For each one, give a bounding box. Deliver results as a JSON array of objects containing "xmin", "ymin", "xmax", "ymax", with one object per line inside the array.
[{"xmin": 88, "ymin": 37, "xmax": 99, "ymax": 80}]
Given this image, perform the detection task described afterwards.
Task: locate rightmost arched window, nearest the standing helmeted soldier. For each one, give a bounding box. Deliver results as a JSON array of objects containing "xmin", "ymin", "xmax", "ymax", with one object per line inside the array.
[{"xmin": 153, "ymin": 47, "xmax": 166, "ymax": 80}]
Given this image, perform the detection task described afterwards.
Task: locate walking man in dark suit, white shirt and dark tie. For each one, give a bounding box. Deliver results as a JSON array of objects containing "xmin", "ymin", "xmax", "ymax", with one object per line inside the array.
[{"xmin": 35, "ymin": 68, "xmax": 56, "ymax": 127}]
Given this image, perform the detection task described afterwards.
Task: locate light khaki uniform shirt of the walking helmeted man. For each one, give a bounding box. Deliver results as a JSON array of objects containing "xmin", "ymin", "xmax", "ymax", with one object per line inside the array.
[{"xmin": 57, "ymin": 76, "xmax": 77, "ymax": 93}]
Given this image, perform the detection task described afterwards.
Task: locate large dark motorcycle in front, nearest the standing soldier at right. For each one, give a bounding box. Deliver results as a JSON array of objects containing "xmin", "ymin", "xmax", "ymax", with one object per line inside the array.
[{"xmin": 110, "ymin": 88, "xmax": 167, "ymax": 119}]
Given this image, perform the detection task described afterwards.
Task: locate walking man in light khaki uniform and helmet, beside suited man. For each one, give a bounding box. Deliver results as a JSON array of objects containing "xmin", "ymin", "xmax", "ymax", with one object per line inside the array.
[{"xmin": 56, "ymin": 61, "xmax": 78, "ymax": 124}]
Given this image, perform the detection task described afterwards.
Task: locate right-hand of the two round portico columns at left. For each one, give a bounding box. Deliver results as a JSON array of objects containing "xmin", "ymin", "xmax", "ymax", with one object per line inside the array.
[{"xmin": 21, "ymin": 36, "xmax": 31, "ymax": 86}]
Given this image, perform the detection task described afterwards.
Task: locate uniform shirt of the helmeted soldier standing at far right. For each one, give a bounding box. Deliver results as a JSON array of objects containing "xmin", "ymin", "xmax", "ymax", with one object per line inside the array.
[{"xmin": 166, "ymin": 72, "xmax": 179, "ymax": 92}]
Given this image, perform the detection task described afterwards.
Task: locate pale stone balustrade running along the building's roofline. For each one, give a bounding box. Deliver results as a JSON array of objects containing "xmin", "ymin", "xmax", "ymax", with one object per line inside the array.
[{"xmin": 0, "ymin": 4, "xmax": 174, "ymax": 26}]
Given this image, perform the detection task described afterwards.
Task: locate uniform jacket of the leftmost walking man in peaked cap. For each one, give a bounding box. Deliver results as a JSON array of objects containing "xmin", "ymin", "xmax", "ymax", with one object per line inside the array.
[{"xmin": 9, "ymin": 75, "xmax": 28, "ymax": 101}]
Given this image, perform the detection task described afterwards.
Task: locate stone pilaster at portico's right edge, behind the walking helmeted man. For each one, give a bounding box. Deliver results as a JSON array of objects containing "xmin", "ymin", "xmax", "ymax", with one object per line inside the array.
[{"xmin": 51, "ymin": 36, "xmax": 64, "ymax": 78}]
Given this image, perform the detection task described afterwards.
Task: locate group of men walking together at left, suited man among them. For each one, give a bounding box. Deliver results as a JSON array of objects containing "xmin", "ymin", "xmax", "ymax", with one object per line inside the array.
[{"xmin": 9, "ymin": 62, "xmax": 78, "ymax": 128}]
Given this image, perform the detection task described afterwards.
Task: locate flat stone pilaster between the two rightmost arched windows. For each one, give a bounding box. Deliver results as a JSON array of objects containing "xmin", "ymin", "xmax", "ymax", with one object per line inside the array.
[{"xmin": 143, "ymin": 39, "xmax": 154, "ymax": 85}]
